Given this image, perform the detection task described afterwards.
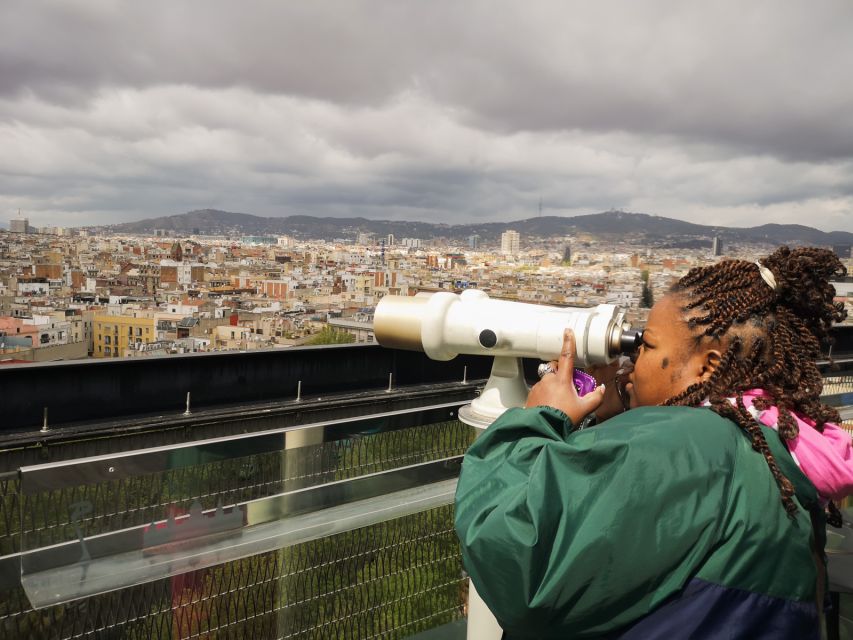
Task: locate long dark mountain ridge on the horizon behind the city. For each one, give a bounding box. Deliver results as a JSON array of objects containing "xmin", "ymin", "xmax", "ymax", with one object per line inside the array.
[{"xmin": 107, "ymin": 209, "xmax": 853, "ymax": 247}]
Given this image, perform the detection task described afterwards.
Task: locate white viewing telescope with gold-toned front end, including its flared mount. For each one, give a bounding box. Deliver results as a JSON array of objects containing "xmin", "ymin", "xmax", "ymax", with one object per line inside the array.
[{"xmin": 373, "ymin": 289, "xmax": 642, "ymax": 429}]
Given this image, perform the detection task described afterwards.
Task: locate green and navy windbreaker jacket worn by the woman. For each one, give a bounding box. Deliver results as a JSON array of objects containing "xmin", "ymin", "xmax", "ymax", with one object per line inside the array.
[{"xmin": 456, "ymin": 407, "xmax": 824, "ymax": 640}]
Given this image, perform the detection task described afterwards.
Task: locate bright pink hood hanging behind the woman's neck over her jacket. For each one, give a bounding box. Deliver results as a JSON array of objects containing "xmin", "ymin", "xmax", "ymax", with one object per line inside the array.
[{"xmin": 743, "ymin": 389, "xmax": 853, "ymax": 500}]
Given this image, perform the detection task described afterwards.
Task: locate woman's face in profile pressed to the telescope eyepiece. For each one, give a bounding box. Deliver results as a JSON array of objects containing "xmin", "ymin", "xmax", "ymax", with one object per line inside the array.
[{"xmin": 625, "ymin": 295, "xmax": 705, "ymax": 408}]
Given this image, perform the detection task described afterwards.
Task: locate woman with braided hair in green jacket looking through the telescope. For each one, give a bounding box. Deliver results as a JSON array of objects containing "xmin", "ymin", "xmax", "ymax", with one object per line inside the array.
[{"xmin": 456, "ymin": 247, "xmax": 853, "ymax": 640}]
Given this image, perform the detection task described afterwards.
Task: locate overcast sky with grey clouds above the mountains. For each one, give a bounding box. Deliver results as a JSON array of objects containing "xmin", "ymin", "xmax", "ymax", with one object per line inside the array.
[{"xmin": 0, "ymin": 0, "xmax": 853, "ymax": 231}]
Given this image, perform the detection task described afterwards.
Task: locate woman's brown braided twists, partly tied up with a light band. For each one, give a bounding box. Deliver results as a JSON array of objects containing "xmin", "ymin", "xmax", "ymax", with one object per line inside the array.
[{"xmin": 665, "ymin": 247, "xmax": 847, "ymax": 526}]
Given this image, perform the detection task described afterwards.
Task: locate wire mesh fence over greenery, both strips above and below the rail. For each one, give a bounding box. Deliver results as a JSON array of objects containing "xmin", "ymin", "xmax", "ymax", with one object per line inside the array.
[{"xmin": 0, "ymin": 420, "xmax": 474, "ymax": 640}]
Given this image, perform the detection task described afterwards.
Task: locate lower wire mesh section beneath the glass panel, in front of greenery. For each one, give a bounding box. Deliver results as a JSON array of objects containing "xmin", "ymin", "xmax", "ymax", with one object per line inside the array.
[{"xmin": 0, "ymin": 506, "xmax": 465, "ymax": 640}]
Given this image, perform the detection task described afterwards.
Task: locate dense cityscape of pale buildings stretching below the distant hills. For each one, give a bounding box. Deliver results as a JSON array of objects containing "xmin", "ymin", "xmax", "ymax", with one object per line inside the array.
[{"xmin": 0, "ymin": 218, "xmax": 853, "ymax": 364}]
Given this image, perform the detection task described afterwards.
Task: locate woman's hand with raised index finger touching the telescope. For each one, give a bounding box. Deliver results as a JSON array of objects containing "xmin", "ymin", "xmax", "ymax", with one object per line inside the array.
[{"xmin": 524, "ymin": 329, "xmax": 607, "ymax": 425}]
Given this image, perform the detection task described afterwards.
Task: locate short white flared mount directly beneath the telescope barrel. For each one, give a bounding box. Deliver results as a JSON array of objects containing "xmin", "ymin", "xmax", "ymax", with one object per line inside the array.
[{"xmin": 459, "ymin": 356, "xmax": 530, "ymax": 429}]
